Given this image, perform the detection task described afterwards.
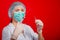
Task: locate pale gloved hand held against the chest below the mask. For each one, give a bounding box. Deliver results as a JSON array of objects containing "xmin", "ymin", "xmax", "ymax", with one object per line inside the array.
[{"xmin": 11, "ymin": 23, "xmax": 24, "ymax": 40}]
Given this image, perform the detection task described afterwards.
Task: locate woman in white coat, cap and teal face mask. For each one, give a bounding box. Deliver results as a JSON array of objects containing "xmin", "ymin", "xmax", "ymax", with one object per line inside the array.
[{"xmin": 2, "ymin": 2, "xmax": 44, "ymax": 40}]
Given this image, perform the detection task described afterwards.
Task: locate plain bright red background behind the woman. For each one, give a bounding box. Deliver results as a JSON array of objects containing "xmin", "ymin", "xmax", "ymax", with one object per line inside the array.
[{"xmin": 0, "ymin": 0, "xmax": 60, "ymax": 40}]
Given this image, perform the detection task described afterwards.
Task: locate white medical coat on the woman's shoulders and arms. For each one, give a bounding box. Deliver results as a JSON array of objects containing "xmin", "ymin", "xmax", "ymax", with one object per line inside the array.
[{"xmin": 2, "ymin": 23, "xmax": 38, "ymax": 40}]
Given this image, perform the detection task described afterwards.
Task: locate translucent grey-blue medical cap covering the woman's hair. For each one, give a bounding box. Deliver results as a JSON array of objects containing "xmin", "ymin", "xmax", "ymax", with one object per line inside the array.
[{"xmin": 8, "ymin": 2, "xmax": 26, "ymax": 18}]
